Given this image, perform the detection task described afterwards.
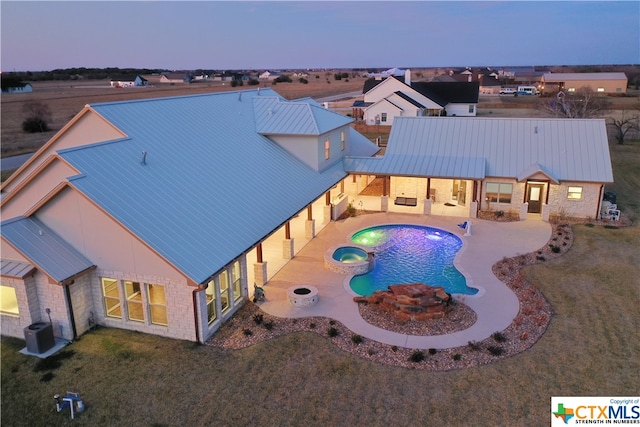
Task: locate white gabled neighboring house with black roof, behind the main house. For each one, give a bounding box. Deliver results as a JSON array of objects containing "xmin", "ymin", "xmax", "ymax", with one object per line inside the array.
[{"xmin": 362, "ymin": 70, "xmax": 479, "ymax": 126}]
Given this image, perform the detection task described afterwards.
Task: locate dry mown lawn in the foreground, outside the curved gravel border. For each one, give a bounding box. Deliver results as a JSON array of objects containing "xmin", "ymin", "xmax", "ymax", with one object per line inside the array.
[{"xmin": 1, "ymin": 141, "xmax": 640, "ymax": 426}]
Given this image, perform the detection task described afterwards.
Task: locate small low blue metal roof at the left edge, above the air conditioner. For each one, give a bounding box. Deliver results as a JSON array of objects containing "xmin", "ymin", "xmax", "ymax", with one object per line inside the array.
[{"xmin": 0, "ymin": 217, "xmax": 94, "ymax": 283}]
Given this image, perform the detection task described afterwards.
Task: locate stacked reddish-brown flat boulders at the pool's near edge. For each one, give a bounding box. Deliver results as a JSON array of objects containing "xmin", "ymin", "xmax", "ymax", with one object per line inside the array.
[{"xmin": 353, "ymin": 283, "xmax": 451, "ymax": 320}]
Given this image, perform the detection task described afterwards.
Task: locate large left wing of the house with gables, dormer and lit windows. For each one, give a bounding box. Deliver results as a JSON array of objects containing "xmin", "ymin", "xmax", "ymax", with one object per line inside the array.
[{"xmin": 0, "ymin": 89, "xmax": 379, "ymax": 342}]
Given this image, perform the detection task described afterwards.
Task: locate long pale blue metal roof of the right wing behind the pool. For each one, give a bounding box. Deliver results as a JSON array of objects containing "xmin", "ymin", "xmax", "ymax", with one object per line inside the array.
[{"xmin": 344, "ymin": 117, "xmax": 613, "ymax": 183}]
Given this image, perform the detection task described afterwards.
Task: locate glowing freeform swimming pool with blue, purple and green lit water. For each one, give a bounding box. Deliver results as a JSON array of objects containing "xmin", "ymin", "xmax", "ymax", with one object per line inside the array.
[{"xmin": 350, "ymin": 224, "xmax": 478, "ymax": 296}]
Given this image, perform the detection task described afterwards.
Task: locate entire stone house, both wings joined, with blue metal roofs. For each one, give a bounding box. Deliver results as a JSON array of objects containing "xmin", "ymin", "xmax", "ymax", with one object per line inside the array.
[{"xmin": 0, "ymin": 88, "xmax": 613, "ymax": 348}]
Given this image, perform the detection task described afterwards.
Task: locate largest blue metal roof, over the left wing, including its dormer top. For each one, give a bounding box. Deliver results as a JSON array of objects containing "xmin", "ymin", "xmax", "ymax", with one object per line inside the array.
[{"xmin": 60, "ymin": 89, "xmax": 350, "ymax": 283}]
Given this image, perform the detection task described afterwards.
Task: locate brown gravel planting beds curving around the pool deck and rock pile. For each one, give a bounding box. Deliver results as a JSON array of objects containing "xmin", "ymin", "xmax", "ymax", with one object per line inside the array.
[{"xmin": 207, "ymin": 224, "xmax": 573, "ymax": 371}]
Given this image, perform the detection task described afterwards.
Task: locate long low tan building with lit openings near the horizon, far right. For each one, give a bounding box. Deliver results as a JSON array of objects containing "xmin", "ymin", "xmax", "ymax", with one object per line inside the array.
[{"xmin": 541, "ymin": 73, "xmax": 628, "ymax": 95}]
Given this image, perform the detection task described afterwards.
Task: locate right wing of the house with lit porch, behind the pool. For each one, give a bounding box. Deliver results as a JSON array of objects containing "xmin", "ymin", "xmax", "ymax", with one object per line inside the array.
[{"xmin": 345, "ymin": 117, "xmax": 613, "ymax": 220}]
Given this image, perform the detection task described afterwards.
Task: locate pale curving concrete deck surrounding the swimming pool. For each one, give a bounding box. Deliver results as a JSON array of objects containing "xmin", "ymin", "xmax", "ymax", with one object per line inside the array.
[{"xmin": 255, "ymin": 213, "xmax": 551, "ymax": 349}]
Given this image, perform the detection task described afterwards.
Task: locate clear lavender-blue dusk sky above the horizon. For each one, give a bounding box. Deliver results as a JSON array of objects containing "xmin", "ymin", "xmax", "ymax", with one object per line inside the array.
[{"xmin": 0, "ymin": 0, "xmax": 640, "ymax": 71}]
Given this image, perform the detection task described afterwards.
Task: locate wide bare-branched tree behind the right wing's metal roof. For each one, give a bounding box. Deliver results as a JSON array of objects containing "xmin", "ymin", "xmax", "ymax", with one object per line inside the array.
[{"xmin": 537, "ymin": 86, "xmax": 611, "ymax": 119}]
